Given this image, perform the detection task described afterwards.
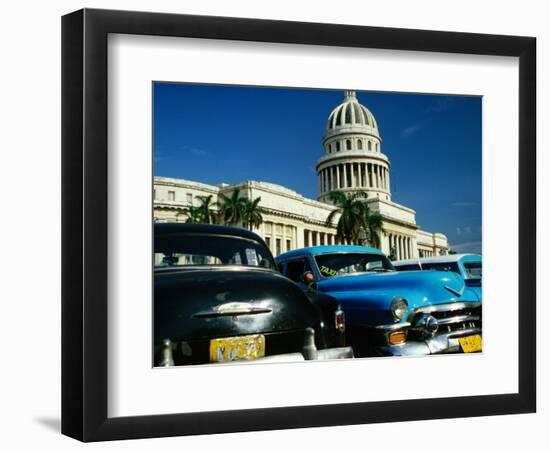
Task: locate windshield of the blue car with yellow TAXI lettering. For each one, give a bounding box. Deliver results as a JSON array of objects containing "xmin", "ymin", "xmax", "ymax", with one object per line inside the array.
[{"xmin": 315, "ymin": 253, "xmax": 395, "ymax": 277}]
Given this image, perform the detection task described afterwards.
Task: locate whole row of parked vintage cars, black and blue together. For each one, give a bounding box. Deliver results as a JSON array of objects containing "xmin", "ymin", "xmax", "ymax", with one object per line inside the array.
[{"xmin": 153, "ymin": 224, "xmax": 482, "ymax": 367}]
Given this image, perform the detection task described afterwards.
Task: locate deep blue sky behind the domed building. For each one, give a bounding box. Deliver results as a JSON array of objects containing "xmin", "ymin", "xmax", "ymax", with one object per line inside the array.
[{"xmin": 153, "ymin": 83, "xmax": 481, "ymax": 252}]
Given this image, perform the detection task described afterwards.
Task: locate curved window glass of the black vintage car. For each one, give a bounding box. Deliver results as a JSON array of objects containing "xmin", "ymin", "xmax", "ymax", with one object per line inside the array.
[{"xmin": 155, "ymin": 234, "xmax": 276, "ymax": 270}]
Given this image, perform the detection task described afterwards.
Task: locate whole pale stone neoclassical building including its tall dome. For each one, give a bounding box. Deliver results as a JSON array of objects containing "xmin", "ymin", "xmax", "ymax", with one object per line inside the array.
[{"xmin": 153, "ymin": 91, "xmax": 449, "ymax": 259}]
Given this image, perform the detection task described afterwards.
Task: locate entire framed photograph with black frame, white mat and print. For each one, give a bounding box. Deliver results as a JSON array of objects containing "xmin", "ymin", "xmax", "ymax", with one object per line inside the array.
[{"xmin": 62, "ymin": 9, "xmax": 536, "ymax": 441}]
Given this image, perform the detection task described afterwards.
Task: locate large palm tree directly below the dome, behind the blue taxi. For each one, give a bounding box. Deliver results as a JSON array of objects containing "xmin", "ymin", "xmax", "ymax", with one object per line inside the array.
[{"xmin": 326, "ymin": 191, "xmax": 367, "ymax": 243}]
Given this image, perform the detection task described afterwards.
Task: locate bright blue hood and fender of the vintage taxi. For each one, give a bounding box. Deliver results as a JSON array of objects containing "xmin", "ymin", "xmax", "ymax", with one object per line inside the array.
[{"xmin": 317, "ymin": 271, "xmax": 479, "ymax": 323}]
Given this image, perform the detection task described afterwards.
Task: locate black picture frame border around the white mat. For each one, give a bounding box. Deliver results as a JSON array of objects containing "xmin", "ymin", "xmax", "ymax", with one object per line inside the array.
[{"xmin": 62, "ymin": 9, "xmax": 536, "ymax": 441}]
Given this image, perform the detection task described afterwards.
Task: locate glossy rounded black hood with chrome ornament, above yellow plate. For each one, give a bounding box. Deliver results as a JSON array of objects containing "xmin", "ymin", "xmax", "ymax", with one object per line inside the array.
[{"xmin": 154, "ymin": 268, "xmax": 319, "ymax": 342}]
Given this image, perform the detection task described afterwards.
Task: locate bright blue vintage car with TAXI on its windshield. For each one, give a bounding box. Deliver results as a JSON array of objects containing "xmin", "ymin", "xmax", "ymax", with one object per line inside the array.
[{"xmin": 276, "ymin": 245, "xmax": 481, "ymax": 356}]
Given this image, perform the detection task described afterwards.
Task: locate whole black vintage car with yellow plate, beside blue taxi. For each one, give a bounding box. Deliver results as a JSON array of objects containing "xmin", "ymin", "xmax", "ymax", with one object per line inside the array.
[{"xmin": 154, "ymin": 224, "xmax": 353, "ymax": 366}]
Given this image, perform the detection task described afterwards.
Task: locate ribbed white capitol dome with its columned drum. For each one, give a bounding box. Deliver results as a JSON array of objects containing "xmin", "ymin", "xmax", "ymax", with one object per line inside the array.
[{"xmin": 316, "ymin": 91, "xmax": 391, "ymax": 203}]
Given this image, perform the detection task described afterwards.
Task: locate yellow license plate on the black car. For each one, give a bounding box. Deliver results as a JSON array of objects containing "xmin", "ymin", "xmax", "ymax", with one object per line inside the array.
[{"xmin": 210, "ymin": 334, "xmax": 265, "ymax": 362}]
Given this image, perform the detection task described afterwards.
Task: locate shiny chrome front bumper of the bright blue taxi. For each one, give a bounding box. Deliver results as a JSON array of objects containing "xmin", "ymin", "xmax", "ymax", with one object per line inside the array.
[{"xmin": 377, "ymin": 328, "xmax": 481, "ymax": 356}]
